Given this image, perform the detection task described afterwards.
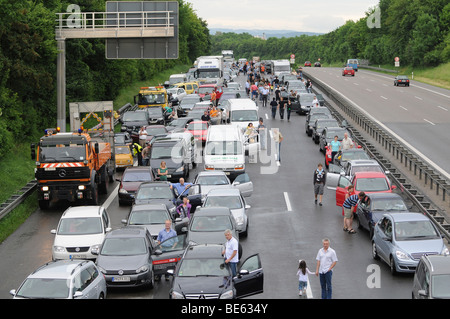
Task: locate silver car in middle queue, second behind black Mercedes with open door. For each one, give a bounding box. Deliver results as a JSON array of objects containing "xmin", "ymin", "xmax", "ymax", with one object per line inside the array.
[{"xmin": 203, "ymin": 188, "xmax": 250, "ymax": 237}]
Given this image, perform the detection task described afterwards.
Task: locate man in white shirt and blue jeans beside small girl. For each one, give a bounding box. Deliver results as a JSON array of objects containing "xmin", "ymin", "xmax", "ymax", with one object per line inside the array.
[{"xmin": 316, "ymin": 238, "xmax": 338, "ymax": 299}]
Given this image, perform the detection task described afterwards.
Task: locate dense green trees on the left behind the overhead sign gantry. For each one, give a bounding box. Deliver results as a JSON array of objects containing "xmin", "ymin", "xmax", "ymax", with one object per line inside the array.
[{"xmin": 0, "ymin": 0, "xmax": 210, "ymax": 158}]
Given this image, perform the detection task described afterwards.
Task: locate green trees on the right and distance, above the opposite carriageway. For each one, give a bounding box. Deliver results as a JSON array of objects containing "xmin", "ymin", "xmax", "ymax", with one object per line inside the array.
[{"xmin": 211, "ymin": 0, "xmax": 450, "ymax": 66}]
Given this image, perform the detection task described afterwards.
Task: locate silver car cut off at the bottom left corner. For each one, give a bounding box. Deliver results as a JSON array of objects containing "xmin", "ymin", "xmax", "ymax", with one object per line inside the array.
[{"xmin": 9, "ymin": 260, "xmax": 106, "ymax": 299}]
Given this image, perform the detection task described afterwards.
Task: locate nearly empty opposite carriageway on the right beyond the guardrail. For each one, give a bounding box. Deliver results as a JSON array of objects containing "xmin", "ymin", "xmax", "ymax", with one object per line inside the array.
[{"xmin": 304, "ymin": 68, "xmax": 450, "ymax": 178}]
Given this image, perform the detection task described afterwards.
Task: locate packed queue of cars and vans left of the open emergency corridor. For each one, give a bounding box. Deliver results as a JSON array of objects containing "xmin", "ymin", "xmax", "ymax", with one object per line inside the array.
[{"xmin": 11, "ymin": 57, "xmax": 263, "ymax": 299}]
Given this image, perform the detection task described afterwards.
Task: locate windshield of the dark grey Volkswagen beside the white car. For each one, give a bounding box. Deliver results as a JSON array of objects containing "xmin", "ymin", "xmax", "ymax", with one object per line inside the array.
[{"xmin": 100, "ymin": 237, "xmax": 147, "ymax": 256}]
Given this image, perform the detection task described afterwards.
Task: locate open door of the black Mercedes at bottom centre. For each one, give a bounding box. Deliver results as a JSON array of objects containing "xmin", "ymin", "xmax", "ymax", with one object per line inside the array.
[{"xmin": 233, "ymin": 254, "xmax": 264, "ymax": 298}]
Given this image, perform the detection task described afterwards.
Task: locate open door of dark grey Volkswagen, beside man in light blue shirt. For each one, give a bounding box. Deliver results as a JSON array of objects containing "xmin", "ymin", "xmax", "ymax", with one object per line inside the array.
[{"xmin": 152, "ymin": 234, "xmax": 188, "ymax": 276}]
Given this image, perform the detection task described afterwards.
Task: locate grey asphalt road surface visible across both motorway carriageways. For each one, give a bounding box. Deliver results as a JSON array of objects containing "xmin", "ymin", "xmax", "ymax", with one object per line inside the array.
[{"xmin": 0, "ymin": 68, "xmax": 442, "ymax": 299}]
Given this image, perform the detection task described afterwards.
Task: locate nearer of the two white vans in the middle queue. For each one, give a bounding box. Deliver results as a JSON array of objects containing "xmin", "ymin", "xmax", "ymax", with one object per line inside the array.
[{"xmin": 204, "ymin": 125, "xmax": 245, "ymax": 180}]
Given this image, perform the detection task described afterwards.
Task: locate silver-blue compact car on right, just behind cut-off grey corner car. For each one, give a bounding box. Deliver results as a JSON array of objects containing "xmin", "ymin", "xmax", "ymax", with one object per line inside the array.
[{"xmin": 372, "ymin": 213, "xmax": 448, "ymax": 274}]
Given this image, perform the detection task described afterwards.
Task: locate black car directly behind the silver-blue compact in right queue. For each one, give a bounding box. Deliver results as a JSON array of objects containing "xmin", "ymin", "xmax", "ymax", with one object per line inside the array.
[{"xmin": 354, "ymin": 193, "xmax": 408, "ymax": 239}]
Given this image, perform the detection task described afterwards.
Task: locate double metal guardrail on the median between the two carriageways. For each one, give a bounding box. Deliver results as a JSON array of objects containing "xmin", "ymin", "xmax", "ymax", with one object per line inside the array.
[{"xmin": 303, "ymin": 72, "xmax": 450, "ymax": 242}]
